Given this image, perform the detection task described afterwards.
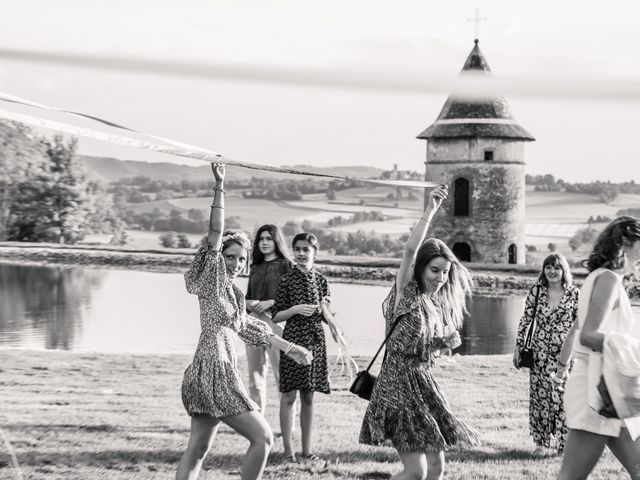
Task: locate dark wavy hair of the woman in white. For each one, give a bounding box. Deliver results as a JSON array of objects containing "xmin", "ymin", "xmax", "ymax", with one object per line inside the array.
[{"xmin": 583, "ymin": 215, "xmax": 640, "ymax": 272}]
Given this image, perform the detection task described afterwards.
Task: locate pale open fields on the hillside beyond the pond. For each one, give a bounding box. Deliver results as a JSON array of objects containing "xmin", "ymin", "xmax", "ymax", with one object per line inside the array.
[{"xmin": 122, "ymin": 187, "xmax": 640, "ymax": 252}]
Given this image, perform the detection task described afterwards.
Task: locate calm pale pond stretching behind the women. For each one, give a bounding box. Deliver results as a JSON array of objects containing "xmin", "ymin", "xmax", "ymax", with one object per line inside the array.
[{"xmin": 0, "ymin": 264, "xmax": 524, "ymax": 356}]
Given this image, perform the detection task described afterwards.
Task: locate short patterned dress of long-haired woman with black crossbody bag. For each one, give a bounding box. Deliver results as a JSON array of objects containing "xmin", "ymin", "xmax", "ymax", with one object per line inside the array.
[{"xmin": 360, "ymin": 280, "xmax": 478, "ymax": 452}]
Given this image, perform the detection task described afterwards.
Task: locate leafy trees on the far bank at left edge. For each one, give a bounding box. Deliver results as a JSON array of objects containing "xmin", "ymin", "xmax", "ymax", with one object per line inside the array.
[{"xmin": 0, "ymin": 121, "xmax": 126, "ymax": 244}]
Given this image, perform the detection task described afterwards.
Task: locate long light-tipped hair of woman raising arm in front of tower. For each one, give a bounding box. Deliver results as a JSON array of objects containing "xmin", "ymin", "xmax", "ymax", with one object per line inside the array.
[{"xmin": 413, "ymin": 238, "xmax": 473, "ymax": 330}]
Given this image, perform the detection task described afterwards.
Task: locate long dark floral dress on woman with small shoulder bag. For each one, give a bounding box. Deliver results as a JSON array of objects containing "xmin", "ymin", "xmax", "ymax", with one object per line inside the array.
[{"xmin": 516, "ymin": 282, "xmax": 580, "ymax": 451}]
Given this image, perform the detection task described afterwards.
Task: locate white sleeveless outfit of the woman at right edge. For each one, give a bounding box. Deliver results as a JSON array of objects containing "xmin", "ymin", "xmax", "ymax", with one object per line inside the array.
[{"xmin": 564, "ymin": 268, "xmax": 640, "ymax": 440}]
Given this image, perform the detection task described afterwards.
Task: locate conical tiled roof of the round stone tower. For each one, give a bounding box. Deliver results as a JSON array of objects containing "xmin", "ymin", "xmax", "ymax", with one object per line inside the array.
[{"xmin": 418, "ymin": 40, "xmax": 535, "ymax": 141}]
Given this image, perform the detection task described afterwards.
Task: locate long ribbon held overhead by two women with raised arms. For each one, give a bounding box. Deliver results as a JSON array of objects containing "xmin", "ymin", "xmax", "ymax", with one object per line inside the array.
[{"xmin": 0, "ymin": 92, "xmax": 439, "ymax": 188}]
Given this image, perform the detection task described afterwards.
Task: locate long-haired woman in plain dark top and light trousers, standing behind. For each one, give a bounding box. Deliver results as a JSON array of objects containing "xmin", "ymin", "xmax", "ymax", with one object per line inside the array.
[{"xmin": 246, "ymin": 223, "xmax": 292, "ymax": 415}]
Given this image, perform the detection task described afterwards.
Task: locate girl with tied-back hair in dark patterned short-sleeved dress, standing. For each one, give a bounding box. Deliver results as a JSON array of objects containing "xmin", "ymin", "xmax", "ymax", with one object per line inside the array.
[{"xmin": 272, "ymin": 233, "xmax": 329, "ymax": 462}]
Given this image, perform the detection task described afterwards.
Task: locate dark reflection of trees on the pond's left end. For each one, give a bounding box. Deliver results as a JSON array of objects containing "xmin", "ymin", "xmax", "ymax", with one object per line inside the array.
[{"xmin": 0, "ymin": 265, "xmax": 105, "ymax": 350}]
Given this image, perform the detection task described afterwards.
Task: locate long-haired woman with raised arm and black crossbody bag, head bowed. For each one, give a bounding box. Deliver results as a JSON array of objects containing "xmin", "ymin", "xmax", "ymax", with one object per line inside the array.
[{"xmin": 360, "ymin": 185, "xmax": 477, "ymax": 480}]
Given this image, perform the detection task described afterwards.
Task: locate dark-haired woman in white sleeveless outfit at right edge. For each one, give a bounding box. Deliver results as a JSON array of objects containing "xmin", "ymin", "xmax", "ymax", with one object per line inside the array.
[{"xmin": 558, "ymin": 216, "xmax": 640, "ymax": 480}]
